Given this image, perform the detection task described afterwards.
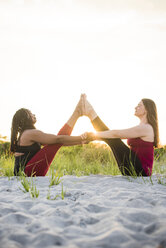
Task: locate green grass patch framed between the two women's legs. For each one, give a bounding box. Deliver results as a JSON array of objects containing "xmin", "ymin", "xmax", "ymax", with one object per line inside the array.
[{"xmin": 48, "ymin": 143, "xmax": 120, "ymax": 176}]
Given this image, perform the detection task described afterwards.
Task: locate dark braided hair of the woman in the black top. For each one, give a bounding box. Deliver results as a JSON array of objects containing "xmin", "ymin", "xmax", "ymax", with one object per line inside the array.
[{"xmin": 10, "ymin": 108, "xmax": 35, "ymax": 152}]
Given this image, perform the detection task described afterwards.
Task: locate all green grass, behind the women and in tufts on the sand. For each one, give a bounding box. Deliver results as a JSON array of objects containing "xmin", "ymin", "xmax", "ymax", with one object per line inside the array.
[{"xmin": 0, "ymin": 142, "xmax": 166, "ymax": 200}]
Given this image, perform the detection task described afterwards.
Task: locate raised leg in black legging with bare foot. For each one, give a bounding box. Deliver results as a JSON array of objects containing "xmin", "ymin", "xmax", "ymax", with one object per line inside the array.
[{"xmin": 82, "ymin": 95, "xmax": 146, "ymax": 176}]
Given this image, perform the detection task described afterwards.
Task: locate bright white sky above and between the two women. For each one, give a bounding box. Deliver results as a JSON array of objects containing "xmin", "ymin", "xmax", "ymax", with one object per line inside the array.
[{"xmin": 0, "ymin": 0, "xmax": 166, "ymax": 145}]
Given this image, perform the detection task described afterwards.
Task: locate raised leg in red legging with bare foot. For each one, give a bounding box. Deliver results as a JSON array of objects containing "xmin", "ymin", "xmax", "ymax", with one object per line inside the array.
[{"xmin": 24, "ymin": 96, "xmax": 83, "ymax": 176}]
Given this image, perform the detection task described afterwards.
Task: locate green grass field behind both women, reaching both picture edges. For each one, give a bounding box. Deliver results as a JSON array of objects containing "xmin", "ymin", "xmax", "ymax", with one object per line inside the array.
[{"xmin": 0, "ymin": 142, "xmax": 166, "ymax": 177}]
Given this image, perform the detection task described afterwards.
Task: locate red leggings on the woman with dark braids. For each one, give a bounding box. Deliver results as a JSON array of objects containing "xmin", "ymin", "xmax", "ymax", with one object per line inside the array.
[{"xmin": 24, "ymin": 124, "xmax": 72, "ymax": 177}]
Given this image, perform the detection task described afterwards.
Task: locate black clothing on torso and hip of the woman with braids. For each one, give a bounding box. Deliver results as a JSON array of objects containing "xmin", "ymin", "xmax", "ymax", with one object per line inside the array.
[{"xmin": 14, "ymin": 142, "xmax": 41, "ymax": 176}]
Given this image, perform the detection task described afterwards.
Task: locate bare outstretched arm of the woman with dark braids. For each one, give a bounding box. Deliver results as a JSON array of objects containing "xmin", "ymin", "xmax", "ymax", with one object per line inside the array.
[{"xmin": 24, "ymin": 129, "xmax": 84, "ymax": 145}]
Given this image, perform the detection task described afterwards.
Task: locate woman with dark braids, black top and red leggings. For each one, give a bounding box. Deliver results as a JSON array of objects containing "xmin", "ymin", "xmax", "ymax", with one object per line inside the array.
[{"xmin": 10, "ymin": 96, "xmax": 86, "ymax": 176}]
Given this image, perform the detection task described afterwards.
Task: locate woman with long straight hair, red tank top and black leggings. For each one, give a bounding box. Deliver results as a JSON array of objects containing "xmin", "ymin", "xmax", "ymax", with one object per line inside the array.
[{"xmin": 82, "ymin": 94, "xmax": 159, "ymax": 176}]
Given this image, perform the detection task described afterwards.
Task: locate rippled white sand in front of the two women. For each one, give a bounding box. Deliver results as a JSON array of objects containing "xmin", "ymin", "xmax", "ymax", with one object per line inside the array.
[{"xmin": 0, "ymin": 175, "xmax": 166, "ymax": 248}]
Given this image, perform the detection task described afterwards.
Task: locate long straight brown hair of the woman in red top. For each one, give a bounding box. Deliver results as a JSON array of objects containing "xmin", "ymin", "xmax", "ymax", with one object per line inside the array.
[{"xmin": 142, "ymin": 98, "xmax": 159, "ymax": 147}]
